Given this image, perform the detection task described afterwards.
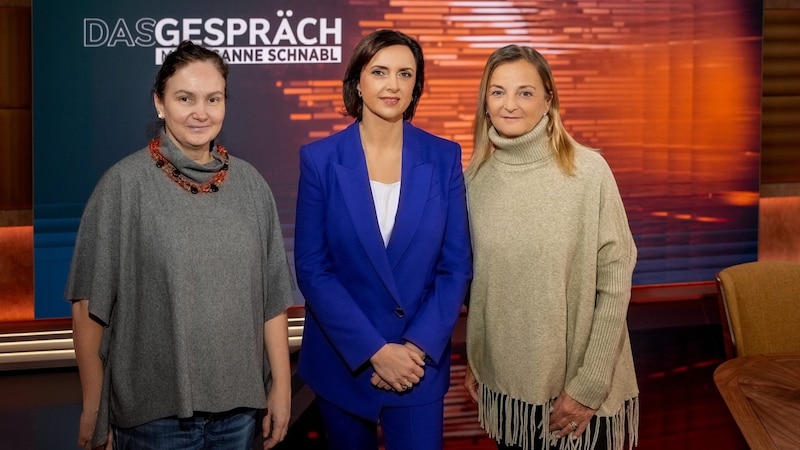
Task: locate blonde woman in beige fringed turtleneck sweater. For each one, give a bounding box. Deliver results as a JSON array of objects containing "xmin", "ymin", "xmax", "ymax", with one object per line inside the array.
[{"xmin": 465, "ymin": 45, "xmax": 639, "ymax": 450}]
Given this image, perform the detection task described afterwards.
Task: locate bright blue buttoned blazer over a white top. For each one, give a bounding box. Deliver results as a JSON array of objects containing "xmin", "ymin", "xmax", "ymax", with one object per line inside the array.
[{"xmin": 294, "ymin": 122, "xmax": 472, "ymax": 420}]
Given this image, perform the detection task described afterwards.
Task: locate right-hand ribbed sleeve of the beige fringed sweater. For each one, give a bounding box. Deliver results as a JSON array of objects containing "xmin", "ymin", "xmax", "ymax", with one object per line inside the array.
[{"xmin": 566, "ymin": 164, "xmax": 636, "ymax": 409}]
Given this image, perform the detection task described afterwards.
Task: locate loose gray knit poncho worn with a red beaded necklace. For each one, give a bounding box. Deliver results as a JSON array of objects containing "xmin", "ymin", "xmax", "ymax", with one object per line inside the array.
[{"xmin": 66, "ymin": 133, "xmax": 293, "ymax": 445}]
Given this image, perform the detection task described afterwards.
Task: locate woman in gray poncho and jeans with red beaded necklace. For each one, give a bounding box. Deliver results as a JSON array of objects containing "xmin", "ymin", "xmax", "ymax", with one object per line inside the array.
[{"xmin": 66, "ymin": 41, "xmax": 292, "ymax": 450}]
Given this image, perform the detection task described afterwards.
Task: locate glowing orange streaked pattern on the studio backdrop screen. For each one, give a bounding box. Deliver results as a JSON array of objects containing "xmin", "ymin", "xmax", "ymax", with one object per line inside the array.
[{"xmin": 279, "ymin": 0, "xmax": 761, "ymax": 282}]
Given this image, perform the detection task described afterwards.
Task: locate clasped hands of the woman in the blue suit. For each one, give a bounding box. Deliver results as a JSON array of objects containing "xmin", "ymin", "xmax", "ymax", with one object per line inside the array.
[{"xmin": 370, "ymin": 342, "xmax": 425, "ymax": 392}]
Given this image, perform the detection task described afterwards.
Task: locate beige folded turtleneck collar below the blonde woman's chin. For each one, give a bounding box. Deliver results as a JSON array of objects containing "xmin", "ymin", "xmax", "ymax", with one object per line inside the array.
[{"xmin": 489, "ymin": 116, "xmax": 552, "ymax": 165}]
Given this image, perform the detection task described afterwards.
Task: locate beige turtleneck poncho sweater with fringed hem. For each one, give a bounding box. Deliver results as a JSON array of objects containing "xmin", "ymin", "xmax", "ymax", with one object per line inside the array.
[{"xmin": 467, "ymin": 117, "xmax": 638, "ymax": 448}]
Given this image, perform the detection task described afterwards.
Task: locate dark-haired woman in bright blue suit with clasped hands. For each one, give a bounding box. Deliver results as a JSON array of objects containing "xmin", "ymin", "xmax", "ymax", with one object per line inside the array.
[{"xmin": 295, "ymin": 30, "xmax": 472, "ymax": 450}]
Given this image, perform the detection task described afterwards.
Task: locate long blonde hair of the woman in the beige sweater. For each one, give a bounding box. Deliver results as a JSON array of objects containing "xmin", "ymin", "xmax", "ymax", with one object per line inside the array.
[{"xmin": 466, "ymin": 45, "xmax": 575, "ymax": 179}]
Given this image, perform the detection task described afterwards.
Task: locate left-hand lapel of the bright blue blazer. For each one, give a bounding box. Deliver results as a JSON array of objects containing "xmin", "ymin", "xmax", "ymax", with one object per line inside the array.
[{"xmin": 334, "ymin": 122, "xmax": 405, "ymax": 302}]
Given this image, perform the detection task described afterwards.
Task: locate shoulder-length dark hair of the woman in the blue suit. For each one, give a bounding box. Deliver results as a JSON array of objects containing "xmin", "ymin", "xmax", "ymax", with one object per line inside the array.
[{"xmin": 342, "ymin": 30, "xmax": 425, "ymax": 121}]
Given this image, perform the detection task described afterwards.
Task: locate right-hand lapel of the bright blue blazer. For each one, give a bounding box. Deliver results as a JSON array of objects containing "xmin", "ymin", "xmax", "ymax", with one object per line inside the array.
[{"xmin": 386, "ymin": 122, "xmax": 433, "ymax": 268}]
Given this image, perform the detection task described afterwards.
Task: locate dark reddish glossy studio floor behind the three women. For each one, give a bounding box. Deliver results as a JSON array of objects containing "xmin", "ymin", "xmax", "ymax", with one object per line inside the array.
[{"xmin": 0, "ymin": 324, "xmax": 747, "ymax": 450}]
